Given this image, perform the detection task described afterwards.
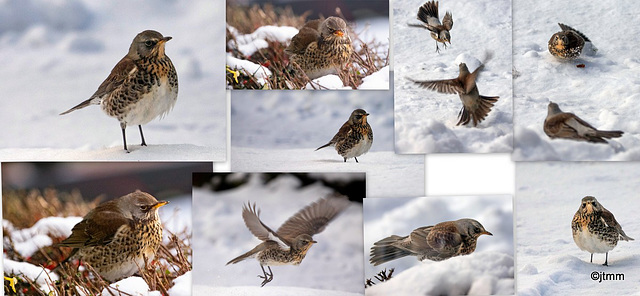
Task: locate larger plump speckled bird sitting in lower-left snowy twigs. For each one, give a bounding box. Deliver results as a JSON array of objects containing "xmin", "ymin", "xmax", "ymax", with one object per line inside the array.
[{"xmin": 57, "ymin": 191, "xmax": 168, "ymax": 281}]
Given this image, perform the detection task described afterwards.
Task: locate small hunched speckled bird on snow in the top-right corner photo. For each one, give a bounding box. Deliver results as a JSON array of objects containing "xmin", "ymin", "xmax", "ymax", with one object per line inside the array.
[{"xmin": 548, "ymin": 23, "xmax": 595, "ymax": 60}]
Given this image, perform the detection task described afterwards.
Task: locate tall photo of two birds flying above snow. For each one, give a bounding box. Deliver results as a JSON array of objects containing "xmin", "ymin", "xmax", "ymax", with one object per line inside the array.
[{"xmin": 392, "ymin": 0, "xmax": 513, "ymax": 154}]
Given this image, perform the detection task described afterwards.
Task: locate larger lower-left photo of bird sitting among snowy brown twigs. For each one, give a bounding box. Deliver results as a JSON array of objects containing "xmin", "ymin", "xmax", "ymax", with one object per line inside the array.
[{"xmin": 2, "ymin": 162, "xmax": 205, "ymax": 295}]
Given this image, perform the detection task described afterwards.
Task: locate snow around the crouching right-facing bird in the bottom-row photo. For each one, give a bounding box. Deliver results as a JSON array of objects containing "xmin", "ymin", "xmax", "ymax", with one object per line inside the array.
[{"xmin": 363, "ymin": 195, "xmax": 515, "ymax": 295}]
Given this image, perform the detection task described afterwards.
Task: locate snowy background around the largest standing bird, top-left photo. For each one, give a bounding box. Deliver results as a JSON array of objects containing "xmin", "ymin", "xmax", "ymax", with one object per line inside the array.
[{"xmin": 0, "ymin": 0, "xmax": 226, "ymax": 160}]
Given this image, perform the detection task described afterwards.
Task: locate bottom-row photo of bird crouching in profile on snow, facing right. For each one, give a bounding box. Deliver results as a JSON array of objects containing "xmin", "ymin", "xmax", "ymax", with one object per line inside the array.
[{"xmin": 363, "ymin": 195, "xmax": 515, "ymax": 295}]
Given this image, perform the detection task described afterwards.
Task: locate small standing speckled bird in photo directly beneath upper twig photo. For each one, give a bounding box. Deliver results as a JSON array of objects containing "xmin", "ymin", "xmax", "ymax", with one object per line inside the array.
[{"xmin": 315, "ymin": 109, "xmax": 373, "ymax": 162}]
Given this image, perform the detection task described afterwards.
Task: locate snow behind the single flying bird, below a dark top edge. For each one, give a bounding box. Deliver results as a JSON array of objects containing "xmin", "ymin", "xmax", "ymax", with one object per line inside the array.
[{"xmin": 193, "ymin": 174, "xmax": 363, "ymax": 295}]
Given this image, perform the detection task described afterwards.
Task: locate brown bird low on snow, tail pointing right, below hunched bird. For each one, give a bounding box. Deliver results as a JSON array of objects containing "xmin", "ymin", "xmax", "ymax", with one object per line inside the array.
[{"xmin": 543, "ymin": 102, "xmax": 624, "ymax": 144}]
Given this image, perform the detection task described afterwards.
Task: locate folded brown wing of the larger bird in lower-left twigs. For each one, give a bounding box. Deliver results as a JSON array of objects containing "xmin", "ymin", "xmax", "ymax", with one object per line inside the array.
[{"xmin": 58, "ymin": 202, "xmax": 133, "ymax": 248}]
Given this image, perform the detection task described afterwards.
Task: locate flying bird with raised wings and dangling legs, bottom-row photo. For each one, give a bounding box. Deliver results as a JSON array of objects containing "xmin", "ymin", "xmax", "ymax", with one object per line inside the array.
[{"xmin": 227, "ymin": 197, "xmax": 349, "ymax": 287}]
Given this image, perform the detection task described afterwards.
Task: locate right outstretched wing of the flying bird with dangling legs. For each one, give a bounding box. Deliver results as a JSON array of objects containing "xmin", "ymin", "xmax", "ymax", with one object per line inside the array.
[{"xmin": 277, "ymin": 196, "xmax": 350, "ymax": 240}]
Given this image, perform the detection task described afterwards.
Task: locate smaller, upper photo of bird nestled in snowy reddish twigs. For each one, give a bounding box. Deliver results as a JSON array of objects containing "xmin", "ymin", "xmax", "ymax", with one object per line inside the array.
[{"xmin": 226, "ymin": 0, "xmax": 390, "ymax": 90}]
